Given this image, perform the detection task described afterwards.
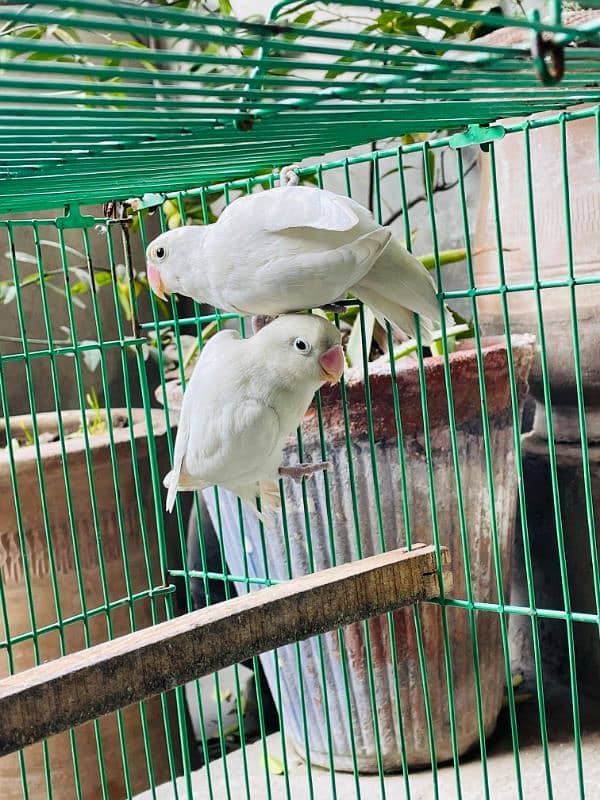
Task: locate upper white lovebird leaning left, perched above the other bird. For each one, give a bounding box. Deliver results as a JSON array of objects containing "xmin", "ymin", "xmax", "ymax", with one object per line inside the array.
[{"xmin": 146, "ymin": 186, "xmax": 453, "ymax": 342}]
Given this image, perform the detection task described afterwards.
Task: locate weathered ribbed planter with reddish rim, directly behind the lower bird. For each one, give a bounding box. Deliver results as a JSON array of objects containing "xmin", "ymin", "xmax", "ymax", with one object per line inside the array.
[{"xmin": 205, "ymin": 336, "xmax": 534, "ymax": 772}]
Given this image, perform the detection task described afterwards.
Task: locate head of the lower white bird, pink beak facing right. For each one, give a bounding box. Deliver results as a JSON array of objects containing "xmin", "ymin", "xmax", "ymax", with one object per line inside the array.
[{"xmin": 253, "ymin": 314, "xmax": 346, "ymax": 389}]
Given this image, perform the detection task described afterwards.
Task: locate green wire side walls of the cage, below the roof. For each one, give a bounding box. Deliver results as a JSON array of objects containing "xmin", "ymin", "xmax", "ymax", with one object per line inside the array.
[{"xmin": 0, "ymin": 101, "xmax": 600, "ymax": 800}]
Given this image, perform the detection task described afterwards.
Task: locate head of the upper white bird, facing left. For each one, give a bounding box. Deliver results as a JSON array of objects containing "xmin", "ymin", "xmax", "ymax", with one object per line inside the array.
[{"xmin": 146, "ymin": 225, "xmax": 203, "ymax": 300}]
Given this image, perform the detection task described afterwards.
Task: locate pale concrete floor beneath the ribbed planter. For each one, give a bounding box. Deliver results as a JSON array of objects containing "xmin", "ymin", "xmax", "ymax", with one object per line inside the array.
[{"xmin": 138, "ymin": 690, "xmax": 600, "ymax": 800}]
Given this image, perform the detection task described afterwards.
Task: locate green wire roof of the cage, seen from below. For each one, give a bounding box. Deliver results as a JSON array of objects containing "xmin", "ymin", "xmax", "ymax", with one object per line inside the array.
[{"xmin": 0, "ymin": 0, "xmax": 600, "ymax": 212}]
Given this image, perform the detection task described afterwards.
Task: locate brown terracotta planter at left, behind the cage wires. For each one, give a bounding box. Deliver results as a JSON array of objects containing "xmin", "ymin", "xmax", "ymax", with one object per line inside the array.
[{"xmin": 0, "ymin": 409, "xmax": 177, "ymax": 800}]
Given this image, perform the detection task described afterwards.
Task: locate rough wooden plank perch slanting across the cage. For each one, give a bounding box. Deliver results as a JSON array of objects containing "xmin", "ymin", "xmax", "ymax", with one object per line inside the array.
[{"xmin": 0, "ymin": 545, "xmax": 452, "ymax": 755}]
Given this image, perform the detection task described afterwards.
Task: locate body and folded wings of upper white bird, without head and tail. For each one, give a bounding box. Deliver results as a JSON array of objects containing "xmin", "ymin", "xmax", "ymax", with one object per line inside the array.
[{"xmin": 203, "ymin": 186, "xmax": 391, "ymax": 315}]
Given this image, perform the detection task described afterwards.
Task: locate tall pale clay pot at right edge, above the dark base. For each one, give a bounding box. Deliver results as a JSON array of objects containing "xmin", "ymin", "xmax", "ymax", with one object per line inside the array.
[{"xmin": 474, "ymin": 109, "xmax": 600, "ymax": 441}]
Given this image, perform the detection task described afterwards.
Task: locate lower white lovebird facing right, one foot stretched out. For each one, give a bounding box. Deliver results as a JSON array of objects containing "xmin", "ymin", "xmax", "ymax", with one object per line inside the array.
[{"xmin": 164, "ymin": 314, "xmax": 345, "ymax": 516}]
